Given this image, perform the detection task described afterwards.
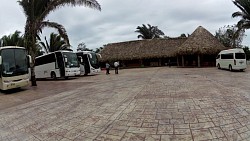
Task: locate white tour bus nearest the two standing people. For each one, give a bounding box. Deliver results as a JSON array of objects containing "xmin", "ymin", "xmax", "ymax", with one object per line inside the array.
[{"xmin": 76, "ymin": 51, "xmax": 101, "ymax": 75}]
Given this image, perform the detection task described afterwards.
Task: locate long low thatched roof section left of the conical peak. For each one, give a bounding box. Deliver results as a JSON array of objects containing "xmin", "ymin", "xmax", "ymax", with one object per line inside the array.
[{"xmin": 101, "ymin": 38, "xmax": 187, "ymax": 61}]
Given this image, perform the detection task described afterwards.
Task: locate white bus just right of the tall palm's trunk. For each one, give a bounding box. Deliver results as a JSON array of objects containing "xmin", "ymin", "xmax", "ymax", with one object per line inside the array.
[{"xmin": 35, "ymin": 50, "xmax": 80, "ymax": 79}]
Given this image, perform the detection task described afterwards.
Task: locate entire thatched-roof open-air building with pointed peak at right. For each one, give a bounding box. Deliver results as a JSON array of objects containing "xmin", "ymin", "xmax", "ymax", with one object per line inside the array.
[{"xmin": 101, "ymin": 26, "xmax": 226, "ymax": 67}]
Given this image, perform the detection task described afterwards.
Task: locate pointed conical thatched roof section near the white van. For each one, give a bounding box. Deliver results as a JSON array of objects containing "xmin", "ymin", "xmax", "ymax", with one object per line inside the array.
[{"xmin": 178, "ymin": 26, "xmax": 226, "ymax": 55}]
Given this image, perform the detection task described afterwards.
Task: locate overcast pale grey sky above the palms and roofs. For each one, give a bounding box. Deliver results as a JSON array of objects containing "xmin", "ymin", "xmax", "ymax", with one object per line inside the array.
[{"xmin": 0, "ymin": 0, "xmax": 250, "ymax": 51}]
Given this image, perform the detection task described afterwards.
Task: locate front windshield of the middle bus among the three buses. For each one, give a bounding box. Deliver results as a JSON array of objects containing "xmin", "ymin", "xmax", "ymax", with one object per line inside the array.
[{"xmin": 63, "ymin": 52, "xmax": 80, "ymax": 68}]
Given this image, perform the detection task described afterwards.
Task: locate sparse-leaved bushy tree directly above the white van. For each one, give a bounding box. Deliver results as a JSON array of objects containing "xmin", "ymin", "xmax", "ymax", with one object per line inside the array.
[{"xmin": 215, "ymin": 25, "xmax": 245, "ymax": 48}]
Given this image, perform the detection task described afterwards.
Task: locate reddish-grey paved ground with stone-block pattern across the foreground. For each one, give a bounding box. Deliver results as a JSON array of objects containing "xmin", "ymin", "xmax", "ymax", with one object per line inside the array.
[{"xmin": 0, "ymin": 67, "xmax": 250, "ymax": 141}]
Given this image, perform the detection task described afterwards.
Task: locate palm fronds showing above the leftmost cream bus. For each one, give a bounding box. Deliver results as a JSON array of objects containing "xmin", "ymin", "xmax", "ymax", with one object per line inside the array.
[{"xmin": 0, "ymin": 31, "xmax": 24, "ymax": 47}]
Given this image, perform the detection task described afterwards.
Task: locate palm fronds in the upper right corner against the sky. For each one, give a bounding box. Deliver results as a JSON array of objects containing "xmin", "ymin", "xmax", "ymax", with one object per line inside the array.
[{"xmin": 232, "ymin": 0, "xmax": 250, "ymax": 29}]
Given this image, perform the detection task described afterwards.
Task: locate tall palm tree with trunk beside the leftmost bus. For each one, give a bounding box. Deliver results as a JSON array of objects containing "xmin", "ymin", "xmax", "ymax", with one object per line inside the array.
[{"xmin": 18, "ymin": 0, "xmax": 101, "ymax": 86}]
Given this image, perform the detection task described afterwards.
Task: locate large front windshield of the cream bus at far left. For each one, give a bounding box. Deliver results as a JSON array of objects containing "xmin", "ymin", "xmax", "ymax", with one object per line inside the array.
[{"xmin": 1, "ymin": 48, "xmax": 28, "ymax": 77}]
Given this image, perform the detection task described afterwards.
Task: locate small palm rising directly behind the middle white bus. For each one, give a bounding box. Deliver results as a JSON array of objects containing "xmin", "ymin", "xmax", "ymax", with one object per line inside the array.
[{"xmin": 39, "ymin": 33, "xmax": 69, "ymax": 53}]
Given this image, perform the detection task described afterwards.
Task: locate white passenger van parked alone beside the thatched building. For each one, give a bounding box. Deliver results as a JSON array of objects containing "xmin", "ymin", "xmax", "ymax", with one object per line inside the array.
[{"xmin": 216, "ymin": 48, "xmax": 247, "ymax": 71}]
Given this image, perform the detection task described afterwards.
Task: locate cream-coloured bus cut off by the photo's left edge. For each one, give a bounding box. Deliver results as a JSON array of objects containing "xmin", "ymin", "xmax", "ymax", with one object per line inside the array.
[{"xmin": 0, "ymin": 46, "xmax": 31, "ymax": 90}]
